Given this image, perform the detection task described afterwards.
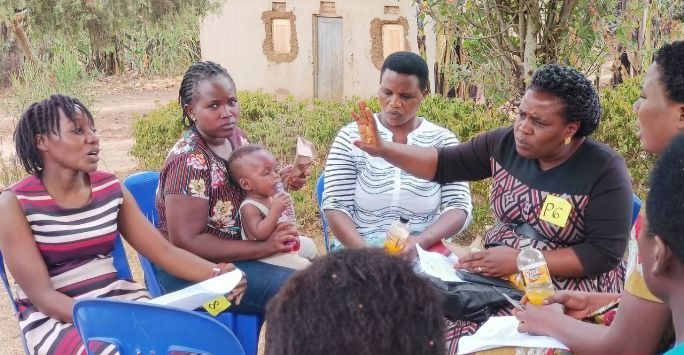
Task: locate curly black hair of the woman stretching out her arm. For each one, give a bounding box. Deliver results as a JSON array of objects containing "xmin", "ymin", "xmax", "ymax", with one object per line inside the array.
[{"xmin": 529, "ymin": 64, "xmax": 603, "ymax": 137}]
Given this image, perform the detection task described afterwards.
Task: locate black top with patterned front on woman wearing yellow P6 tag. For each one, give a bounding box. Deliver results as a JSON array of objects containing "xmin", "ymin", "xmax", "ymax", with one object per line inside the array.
[{"xmin": 435, "ymin": 126, "xmax": 632, "ymax": 292}]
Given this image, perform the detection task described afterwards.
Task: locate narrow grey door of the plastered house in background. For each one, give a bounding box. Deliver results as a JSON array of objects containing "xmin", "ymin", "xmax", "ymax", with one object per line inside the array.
[{"xmin": 314, "ymin": 17, "xmax": 344, "ymax": 99}]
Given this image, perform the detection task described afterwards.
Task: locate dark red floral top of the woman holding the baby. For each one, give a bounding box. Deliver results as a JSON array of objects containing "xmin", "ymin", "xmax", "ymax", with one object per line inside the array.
[{"xmin": 155, "ymin": 128, "xmax": 249, "ymax": 240}]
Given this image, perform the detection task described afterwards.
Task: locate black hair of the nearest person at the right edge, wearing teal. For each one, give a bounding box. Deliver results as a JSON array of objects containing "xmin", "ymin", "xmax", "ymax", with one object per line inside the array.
[{"xmin": 646, "ymin": 133, "xmax": 684, "ymax": 263}]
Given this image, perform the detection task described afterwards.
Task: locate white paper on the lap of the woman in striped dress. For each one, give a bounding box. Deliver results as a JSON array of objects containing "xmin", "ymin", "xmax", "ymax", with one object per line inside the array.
[{"xmin": 150, "ymin": 269, "xmax": 242, "ymax": 310}]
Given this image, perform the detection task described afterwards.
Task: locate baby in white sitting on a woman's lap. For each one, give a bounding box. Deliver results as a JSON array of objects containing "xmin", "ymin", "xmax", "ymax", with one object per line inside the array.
[{"xmin": 228, "ymin": 145, "xmax": 317, "ymax": 270}]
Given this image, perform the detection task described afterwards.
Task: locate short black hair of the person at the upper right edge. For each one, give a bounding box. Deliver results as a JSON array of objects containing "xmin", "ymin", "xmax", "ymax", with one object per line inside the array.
[{"xmin": 655, "ymin": 41, "xmax": 684, "ymax": 103}]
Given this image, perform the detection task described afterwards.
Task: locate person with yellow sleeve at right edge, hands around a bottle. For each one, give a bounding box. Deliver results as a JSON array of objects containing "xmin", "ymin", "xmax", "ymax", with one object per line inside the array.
[{"xmin": 517, "ymin": 41, "xmax": 684, "ymax": 355}]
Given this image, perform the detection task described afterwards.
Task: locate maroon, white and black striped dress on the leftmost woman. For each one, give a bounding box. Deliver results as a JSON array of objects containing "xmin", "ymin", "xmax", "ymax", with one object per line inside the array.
[{"xmin": 9, "ymin": 171, "xmax": 149, "ymax": 355}]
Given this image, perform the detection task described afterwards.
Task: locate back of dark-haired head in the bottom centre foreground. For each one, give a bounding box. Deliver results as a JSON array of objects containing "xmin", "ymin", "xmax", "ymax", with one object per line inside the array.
[{"xmin": 266, "ymin": 249, "xmax": 446, "ymax": 355}]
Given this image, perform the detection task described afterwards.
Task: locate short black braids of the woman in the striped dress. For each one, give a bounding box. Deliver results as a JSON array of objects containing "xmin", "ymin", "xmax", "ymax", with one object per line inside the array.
[{"xmin": 14, "ymin": 94, "xmax": 94, "ymax": 176}]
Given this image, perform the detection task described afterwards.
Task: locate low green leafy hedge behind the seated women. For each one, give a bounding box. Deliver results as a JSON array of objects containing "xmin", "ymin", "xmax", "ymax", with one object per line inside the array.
[{"xmin": 131, "ymin": 79, "xmax": 652, "ymax": 241}]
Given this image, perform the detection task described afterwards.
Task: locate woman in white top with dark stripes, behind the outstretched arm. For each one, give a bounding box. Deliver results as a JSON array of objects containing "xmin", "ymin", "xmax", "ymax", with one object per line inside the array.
[{"xmin": 323, "ymin": 52, "xmax": 472, "ymax": 259}]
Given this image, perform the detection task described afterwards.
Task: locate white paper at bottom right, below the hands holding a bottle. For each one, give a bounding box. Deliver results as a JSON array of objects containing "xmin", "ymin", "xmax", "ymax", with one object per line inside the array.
[{"xmin": 458, "ymin": 316, "xmax": 569, "ymax": 355}]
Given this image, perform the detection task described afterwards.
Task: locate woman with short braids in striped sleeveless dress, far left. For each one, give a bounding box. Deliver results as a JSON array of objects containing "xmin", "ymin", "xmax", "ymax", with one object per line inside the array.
[{"xmin": 0, "ymin": 95, "xmax": 245, "ymax": 355}]
